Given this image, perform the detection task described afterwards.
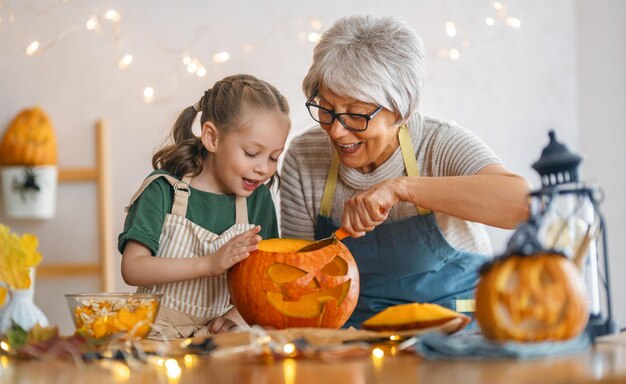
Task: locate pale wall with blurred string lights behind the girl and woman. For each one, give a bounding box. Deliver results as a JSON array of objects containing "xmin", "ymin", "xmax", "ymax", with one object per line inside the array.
[{"xmin": 0, "ymin": 0, "xmax": 626, "ymax": 333}]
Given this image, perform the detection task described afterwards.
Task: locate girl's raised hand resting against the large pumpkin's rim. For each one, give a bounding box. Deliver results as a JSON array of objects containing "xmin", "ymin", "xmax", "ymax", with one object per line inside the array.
[{"xmin": 204, "ymin": 225, "xmax": 261, "ymax": 276}]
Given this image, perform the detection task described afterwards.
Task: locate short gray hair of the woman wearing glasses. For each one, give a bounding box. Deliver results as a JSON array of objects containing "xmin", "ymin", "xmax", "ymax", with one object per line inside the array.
[{"xmin": 302, "ymin": 15, "xmax": 425, "ymax": 124}]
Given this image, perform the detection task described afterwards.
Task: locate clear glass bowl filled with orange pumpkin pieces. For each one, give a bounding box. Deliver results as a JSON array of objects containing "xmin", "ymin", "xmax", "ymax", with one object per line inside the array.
[{"xmin": 65, "ymin": 293, "xmax": 163, "ymax": 339}]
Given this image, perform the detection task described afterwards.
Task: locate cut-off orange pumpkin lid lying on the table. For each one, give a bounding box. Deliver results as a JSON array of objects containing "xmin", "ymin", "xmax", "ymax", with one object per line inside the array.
[{"xmin": 362, "ymin": 303, "xmax": 470, "ymax": 331}]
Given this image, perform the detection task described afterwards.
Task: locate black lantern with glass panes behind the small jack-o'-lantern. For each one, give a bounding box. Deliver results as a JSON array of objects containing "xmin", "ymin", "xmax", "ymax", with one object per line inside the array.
[{"xmin": 529, "ymin": 130, "xmax": 619, "ymax": 338}]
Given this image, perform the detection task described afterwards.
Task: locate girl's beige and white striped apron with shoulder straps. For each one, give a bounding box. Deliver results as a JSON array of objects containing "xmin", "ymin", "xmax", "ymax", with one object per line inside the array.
[{"xmin": 124, "ymin": 174, "xmax": 254, "ymax": 338}]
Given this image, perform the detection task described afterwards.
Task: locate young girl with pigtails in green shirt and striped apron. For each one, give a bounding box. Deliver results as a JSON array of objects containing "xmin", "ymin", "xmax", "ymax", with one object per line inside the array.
[{"xmin": 118, "ymin": 75, "xmax": 290, "ymax": 338}]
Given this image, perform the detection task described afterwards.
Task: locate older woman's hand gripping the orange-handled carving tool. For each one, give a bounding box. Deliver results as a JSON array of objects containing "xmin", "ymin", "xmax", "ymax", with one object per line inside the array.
[{"xmin": 341, "ymin": 180, "xmax": 398, "ymax": 237}]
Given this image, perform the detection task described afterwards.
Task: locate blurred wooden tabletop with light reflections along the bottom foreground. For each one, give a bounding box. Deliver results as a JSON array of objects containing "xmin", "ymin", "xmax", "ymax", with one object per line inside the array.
[{"xmin": 0, "ymin": 333, "xmax": 626, "ymax": 384}]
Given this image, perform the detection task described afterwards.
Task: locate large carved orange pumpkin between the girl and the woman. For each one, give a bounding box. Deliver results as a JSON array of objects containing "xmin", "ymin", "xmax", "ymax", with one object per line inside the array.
[{"xmin": 228, "ymin": 239, "xmax": 359, "ymax": 329}]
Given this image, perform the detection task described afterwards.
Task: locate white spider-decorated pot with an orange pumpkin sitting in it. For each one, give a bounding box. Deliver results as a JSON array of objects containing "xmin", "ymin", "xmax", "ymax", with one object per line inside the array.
[{"xmin": 0, "ymin": 107, "xmax": 57, "ymax": 218}]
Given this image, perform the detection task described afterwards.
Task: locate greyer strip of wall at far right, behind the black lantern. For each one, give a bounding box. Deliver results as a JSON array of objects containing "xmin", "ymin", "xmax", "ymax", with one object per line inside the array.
[{"xmin": 577, "ymin": 0, "xmax": 626, "ymax": 327}]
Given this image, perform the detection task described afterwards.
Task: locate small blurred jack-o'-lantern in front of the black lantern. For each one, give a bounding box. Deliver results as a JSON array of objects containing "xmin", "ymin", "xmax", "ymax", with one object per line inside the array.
[{"xmin": 475, "ymin": 251, "xmax": 589, "ymax": 342}]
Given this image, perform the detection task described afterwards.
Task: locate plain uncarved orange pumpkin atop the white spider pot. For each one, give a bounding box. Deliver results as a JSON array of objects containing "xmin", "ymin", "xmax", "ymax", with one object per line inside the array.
[{"xmin": 0, "ymin": 107, "xmax": 57, "ymax": 166}]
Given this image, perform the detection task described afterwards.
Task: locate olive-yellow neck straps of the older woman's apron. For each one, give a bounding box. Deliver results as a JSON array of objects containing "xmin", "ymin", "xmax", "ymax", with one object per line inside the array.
[{"xmin": 320, "ymin": 125, "xmax": 430, "ymax": 218}]
